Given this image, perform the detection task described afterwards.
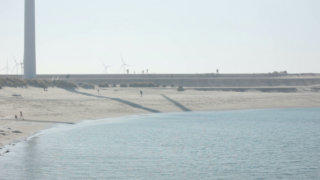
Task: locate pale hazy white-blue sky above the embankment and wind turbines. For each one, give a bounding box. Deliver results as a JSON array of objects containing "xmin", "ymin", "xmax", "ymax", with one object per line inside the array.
[{"xmin": 0, "ymin": 0, "xmax": 320, "ymax": 74}]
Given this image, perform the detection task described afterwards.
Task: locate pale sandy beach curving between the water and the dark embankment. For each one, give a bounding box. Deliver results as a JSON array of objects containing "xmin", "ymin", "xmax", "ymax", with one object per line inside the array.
[{"xmin": 0, "ymin": 87, "xmax": 320, "ymax": 147}]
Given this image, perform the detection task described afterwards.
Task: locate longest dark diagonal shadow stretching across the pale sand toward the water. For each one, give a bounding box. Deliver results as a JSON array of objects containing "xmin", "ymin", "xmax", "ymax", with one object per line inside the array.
[{"xmin": 69, "ymin": 90, "xmax": 161, "ymax": 113}]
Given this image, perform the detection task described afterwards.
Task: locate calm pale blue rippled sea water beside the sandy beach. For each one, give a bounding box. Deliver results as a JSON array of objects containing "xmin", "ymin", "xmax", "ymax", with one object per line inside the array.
[{"xmin": 0, "ymin": 108, "xmax": 320, "ymax": 179}]
